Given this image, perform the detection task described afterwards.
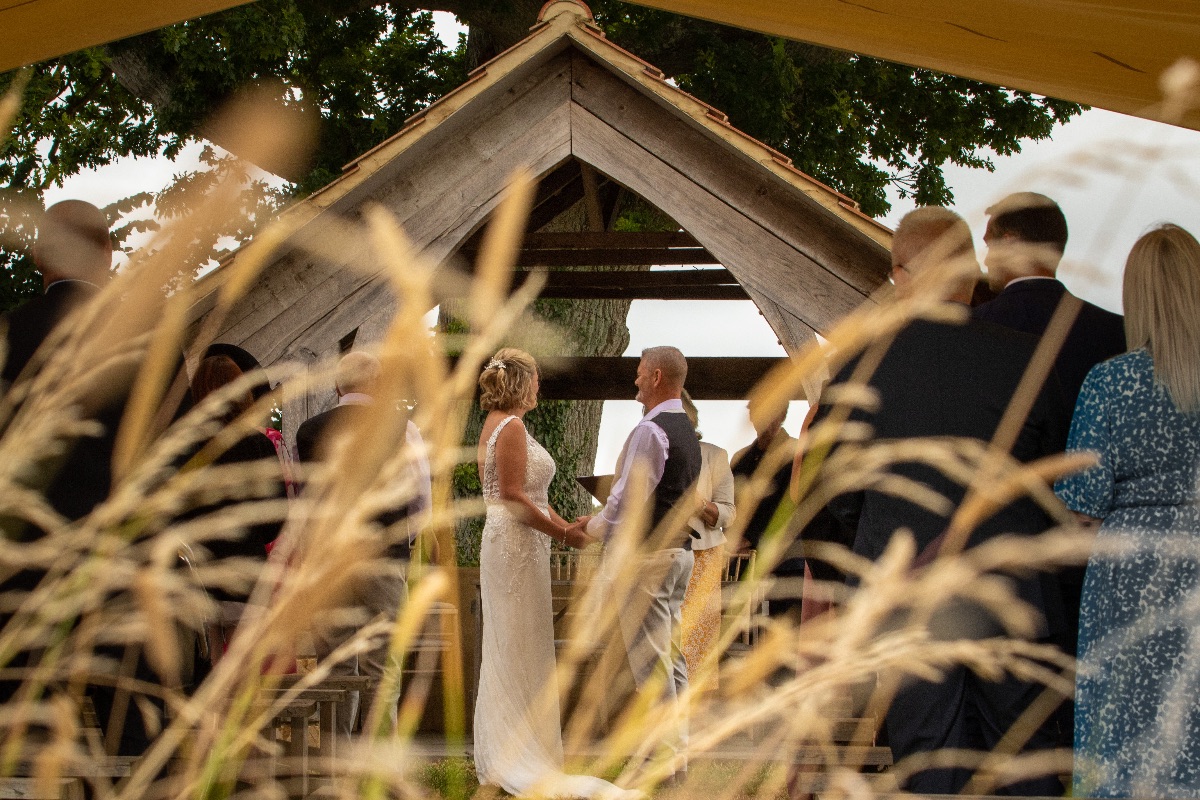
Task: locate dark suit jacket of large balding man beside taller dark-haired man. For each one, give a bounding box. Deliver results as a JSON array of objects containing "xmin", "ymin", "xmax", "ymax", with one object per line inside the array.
[{"xmin": 817, "ymin": 319, "xmax": 1070, "ymax": 632}]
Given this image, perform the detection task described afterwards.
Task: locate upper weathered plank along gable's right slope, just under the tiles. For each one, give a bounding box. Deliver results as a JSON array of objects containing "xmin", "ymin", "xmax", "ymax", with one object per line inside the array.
[{"xmin": 571, "ymin": 55, "xmax": 890, "ymax": 295}]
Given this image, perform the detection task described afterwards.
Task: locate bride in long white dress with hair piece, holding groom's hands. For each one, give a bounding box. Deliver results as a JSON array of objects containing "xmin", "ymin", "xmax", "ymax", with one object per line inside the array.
[{"xmin": 475, "ymin": 348, "xmax": 642, "ymax": 800}]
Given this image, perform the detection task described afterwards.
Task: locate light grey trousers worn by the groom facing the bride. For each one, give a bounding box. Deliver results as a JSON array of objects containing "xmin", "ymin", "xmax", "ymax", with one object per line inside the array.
[{"xmin": 620, "ymin": 548, "xmax": 696, "ymax": 753}]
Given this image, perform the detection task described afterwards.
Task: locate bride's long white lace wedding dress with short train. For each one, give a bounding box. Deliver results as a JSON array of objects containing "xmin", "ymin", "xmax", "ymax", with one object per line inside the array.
[{"xmin": 475, "ymin": 416, "xmax": 642, "ymax": 800}]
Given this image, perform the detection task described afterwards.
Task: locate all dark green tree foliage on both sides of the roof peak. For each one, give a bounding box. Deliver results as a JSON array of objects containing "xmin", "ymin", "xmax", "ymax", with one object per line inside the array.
[{"xmin": 0, "ymin": 0, "xmax": 1080, "ymax": 308}]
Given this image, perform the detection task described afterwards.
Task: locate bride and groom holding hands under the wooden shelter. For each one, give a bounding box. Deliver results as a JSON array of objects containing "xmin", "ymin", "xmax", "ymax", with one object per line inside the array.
[{"xmin": 474, "ymin": 347, "xmax": 701, "ymax": 800}]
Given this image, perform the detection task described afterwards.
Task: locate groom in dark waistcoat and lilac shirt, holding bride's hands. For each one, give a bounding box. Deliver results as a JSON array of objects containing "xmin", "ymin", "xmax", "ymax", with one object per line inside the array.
[{"xmin": 587, "ymin": 347, "xmax": 700, "ymax": 772}]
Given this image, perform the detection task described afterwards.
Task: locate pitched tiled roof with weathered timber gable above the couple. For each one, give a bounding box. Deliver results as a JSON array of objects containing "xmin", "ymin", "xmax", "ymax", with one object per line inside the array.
[{"xmin": 193, "ymin": 0, "xmax": 890, "ymax": 363}]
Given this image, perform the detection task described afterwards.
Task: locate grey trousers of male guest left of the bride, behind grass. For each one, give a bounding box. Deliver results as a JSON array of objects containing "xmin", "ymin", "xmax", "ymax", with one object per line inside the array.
[{"xmin": 312, "ymin": 563, "xmax": 408, "ymax": 738}]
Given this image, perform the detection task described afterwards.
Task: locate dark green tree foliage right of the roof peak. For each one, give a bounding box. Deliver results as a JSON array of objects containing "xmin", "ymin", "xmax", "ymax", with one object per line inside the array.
[{"xmin": 593, "ymin": 0, "xmax": 1081, "ymax": 216}]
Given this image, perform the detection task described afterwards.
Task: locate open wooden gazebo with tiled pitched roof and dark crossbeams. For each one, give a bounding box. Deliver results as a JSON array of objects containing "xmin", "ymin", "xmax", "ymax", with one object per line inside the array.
[{"xmin": 193, "ymin": 0, "xmax": 890, "ymax": 443}]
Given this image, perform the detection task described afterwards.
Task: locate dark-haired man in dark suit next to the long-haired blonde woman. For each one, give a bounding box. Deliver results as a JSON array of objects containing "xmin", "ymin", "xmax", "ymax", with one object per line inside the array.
[{"xmin": 972, "ymin": 192, "xmax": 1126, "ymax": 411}]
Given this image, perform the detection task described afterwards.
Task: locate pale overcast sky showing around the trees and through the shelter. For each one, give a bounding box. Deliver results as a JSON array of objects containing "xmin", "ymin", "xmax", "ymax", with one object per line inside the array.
[{"xmin": 47, "ymin": 14, "xmax": 1200, "ymax": 473}]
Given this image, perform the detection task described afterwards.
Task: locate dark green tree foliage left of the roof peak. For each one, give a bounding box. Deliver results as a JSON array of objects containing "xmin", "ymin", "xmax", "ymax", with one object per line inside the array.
[{"xmin": 0, "ymin": 0, "xmax": 466, "ymax": 309}]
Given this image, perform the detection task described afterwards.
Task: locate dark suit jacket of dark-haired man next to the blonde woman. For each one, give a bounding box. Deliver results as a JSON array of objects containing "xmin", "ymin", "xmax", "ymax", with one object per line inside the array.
[{"xmin": 972, "ymin": 278, "xmax": 1126, "ymax": 411}]
